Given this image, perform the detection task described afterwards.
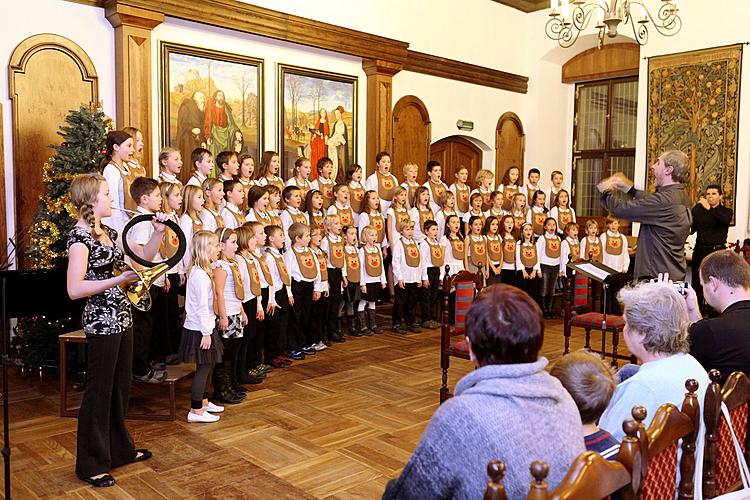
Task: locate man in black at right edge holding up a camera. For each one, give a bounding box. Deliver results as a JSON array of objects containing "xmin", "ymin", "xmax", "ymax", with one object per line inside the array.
[{"xmin": 685, "ymin": 250, "xmax": 750, "ymax": 384}]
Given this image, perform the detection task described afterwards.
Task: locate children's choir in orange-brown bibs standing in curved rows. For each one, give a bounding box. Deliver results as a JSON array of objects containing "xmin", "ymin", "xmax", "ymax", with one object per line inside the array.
[{"xmin": 102, "ymin": 127, "xmax": 629, "ymax": 422}]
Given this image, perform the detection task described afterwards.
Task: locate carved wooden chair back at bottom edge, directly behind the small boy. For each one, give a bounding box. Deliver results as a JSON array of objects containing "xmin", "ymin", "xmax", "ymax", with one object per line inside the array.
[{"xmin": 524, "ymin": 414, "xmax": 643, "ymax": 500}]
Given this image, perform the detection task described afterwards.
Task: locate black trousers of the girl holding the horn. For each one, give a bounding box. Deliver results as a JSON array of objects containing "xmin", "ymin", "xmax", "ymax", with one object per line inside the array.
[{"xmin": 76, "ymin": 329, "xmax": 136, "ymax": 478}]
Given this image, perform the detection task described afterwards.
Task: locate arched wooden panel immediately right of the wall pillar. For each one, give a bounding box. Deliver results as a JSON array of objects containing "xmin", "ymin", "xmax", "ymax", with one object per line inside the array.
[{"xmin": 391, "ymin": 95, "xmax": 432, "ymax": 182}]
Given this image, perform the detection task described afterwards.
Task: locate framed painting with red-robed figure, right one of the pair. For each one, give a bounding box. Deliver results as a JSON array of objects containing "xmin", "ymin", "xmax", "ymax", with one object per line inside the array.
[{"xmin": 277, "ymin": 64, "xmax": 357, "ymax": 182}]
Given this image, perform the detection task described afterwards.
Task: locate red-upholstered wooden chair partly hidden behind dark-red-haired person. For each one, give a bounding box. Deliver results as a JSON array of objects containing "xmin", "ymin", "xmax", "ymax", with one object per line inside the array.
[{"xmin": 440, "ymin": 271, "xmax": 482, "ymax": 403}]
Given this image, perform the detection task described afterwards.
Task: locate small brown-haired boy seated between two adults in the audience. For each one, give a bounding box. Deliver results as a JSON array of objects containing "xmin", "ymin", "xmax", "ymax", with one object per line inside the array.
[{"xmin": 550, "ymin": 351, "xmax": 620, "ymax": 460}]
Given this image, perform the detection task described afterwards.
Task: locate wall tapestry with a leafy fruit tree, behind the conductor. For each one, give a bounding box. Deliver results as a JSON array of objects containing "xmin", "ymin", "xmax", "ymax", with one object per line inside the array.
[{"xmin": 646, "ymin": 45, "xmax": 742, "ymax": 224}]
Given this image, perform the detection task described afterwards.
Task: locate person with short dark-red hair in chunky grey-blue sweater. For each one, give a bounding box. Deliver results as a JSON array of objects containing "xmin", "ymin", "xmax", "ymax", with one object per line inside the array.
[{"xmin": 383, "ymin": 284, "xmax": 588, "ymax": 499}]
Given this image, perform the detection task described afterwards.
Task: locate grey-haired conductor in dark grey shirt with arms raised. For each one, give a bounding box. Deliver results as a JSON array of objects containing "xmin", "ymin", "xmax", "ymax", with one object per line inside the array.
[{"xmin": 597, "ymin": 150, "xmax": 693, "ymax": 281}]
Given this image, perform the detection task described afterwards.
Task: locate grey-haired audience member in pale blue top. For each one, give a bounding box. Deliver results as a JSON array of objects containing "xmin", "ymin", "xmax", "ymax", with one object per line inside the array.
[{"xmin": 599, "ymin": 282, "xmax": 709, "ymax": 442}]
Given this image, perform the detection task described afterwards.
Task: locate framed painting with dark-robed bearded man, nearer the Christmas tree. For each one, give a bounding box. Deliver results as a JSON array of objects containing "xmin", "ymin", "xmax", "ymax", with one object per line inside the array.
[{"xmin": 159, "ymin": 42, "xmax": 263, "ymax": 182}]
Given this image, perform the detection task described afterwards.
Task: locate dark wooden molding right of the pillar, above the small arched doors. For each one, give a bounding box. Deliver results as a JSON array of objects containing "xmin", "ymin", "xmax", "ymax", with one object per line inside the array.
[{"xmin": 404, "ymin": 50, "xmax": 529, "ymax": 94}]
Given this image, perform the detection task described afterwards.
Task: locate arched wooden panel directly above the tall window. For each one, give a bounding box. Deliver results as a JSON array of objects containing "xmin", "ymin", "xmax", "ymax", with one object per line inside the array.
[{"xmin": 562, "ymin": 43, "xmax": 641, "ymax": 83}]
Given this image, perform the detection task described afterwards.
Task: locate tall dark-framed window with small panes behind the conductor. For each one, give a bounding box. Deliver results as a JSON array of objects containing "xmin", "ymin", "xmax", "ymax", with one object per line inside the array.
[{"xmin": 572, "ymin": 77, "xmax": 638, "ymax": 217}]
